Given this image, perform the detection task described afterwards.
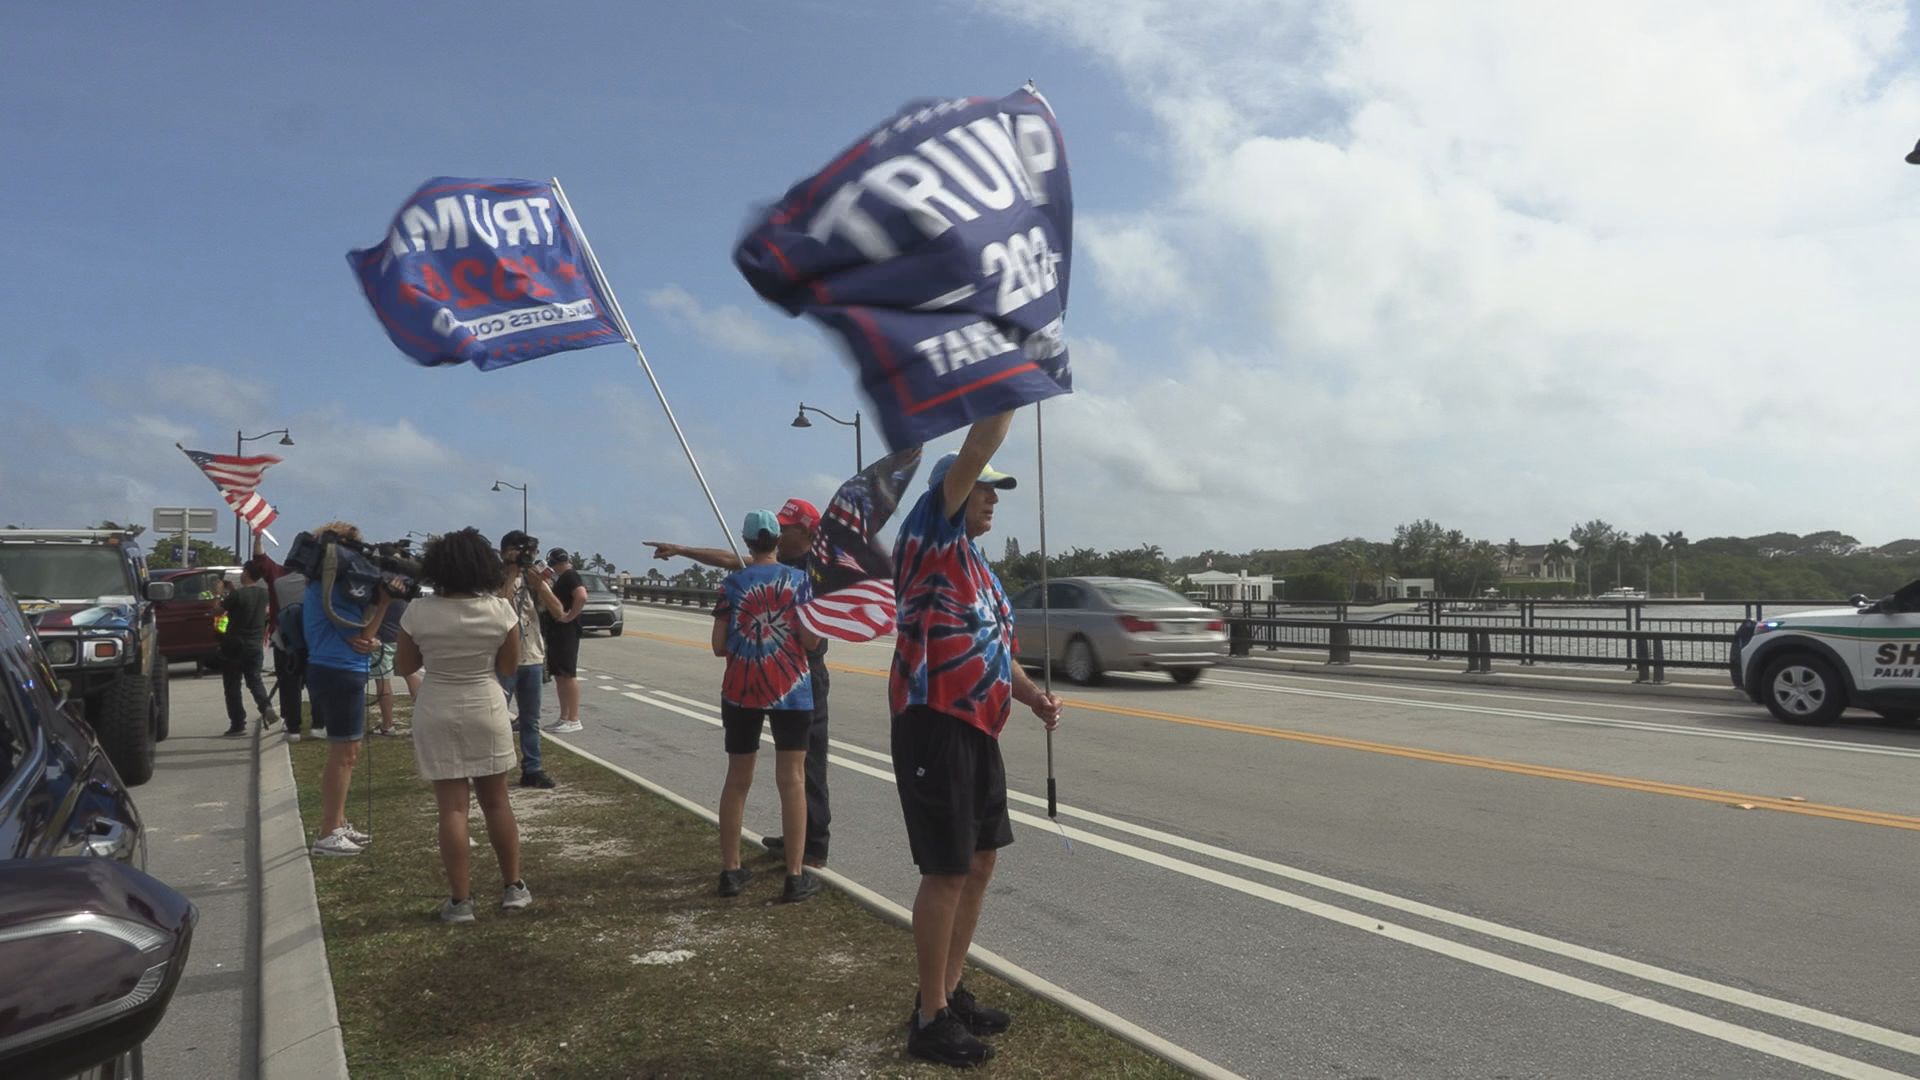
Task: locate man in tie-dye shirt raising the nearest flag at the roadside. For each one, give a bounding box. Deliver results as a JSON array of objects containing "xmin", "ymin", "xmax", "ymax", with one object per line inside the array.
[{"xmin": 887, "ymin": 413, "xmax": 1060, "ymax": 1067}]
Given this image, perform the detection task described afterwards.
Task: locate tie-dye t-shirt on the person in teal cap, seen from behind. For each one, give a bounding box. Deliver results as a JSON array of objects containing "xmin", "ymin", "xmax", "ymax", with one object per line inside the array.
[{"xmin": 714, "ymin": 563, "xmax": 814, "ymax": 711}]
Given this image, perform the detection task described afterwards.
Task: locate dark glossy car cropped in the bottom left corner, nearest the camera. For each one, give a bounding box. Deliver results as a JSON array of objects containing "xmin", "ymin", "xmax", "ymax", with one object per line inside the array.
[{"xmin": 0, "ymin": 580, "xmax": 198, "ymax": 1080}]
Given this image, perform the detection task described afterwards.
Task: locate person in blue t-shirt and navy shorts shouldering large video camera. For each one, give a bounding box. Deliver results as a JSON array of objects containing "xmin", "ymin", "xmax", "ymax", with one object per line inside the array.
[{"xmin": 301, "ymin": 521, "xmax": 392, "ymax": 855}]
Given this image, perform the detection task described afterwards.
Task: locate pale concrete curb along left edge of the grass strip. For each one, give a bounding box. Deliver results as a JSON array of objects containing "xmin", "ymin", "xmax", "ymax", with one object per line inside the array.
[{"xmin": 253, "ymin": 728, "xmax": 348, "ymax": 1080}]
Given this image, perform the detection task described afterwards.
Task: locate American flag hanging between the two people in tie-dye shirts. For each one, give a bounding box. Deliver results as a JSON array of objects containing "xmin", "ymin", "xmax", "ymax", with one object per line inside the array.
[{"xmin": 801, "ymin": 446, "xmax": 920, "ymax": 642}]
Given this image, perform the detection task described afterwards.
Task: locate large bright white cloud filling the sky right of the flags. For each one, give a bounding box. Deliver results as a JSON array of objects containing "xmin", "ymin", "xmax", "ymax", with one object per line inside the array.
[{"xmin": 989, "ymin": 0, "xmax": 1920, "ymax": 552}]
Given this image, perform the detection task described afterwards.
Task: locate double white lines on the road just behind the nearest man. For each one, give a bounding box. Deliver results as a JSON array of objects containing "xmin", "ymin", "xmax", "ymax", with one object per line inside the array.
[{"xmin": 583, "ymin": 690, "xmax": 1920, "ymax": 1080}]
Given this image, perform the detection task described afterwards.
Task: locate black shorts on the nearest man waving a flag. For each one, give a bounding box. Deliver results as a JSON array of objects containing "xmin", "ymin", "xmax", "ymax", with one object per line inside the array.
[{"xmin": 893, "ymin": 705, "xmax": 1014, "ymax": 874}]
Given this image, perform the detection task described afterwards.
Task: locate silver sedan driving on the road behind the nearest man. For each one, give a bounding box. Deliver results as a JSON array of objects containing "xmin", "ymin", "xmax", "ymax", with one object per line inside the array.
[{"xmin": 1014, "ymin": 577, "xmax": 1227, "ymax": 686}]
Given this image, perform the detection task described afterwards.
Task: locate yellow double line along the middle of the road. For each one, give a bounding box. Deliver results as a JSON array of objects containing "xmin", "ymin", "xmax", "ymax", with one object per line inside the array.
[{"xmin": 628, "ymin": 630, "xmax": 1920, "ymax": 832}]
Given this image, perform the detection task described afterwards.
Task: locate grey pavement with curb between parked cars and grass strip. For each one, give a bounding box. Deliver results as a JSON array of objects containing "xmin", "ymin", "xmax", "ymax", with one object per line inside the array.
[{"xmin": 134, "ymin": 667, "xmax": 348, "ymax": 1080}]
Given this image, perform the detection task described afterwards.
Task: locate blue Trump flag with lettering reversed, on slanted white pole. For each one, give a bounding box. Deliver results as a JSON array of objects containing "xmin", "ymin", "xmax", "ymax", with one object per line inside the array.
[{"xmin": 348, "ymin": 177, "xmax": 626, "ymax": 371}]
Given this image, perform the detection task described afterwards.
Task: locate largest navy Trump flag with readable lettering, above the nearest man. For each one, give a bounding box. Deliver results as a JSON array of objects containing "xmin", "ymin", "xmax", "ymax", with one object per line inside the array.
[{"xmin": 733, "ymin": 86, "xmax": 1073, "ymax": 450}]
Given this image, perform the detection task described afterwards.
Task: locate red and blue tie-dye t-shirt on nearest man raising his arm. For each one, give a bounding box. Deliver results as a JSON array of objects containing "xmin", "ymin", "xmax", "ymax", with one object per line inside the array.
[{"xmin": 887, "ymin": 488, "xmax": 1014, "ymax": 738}]
